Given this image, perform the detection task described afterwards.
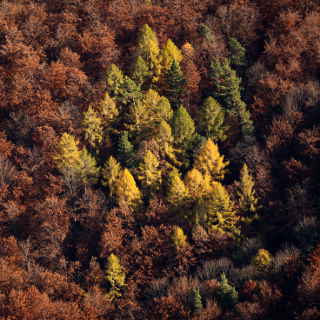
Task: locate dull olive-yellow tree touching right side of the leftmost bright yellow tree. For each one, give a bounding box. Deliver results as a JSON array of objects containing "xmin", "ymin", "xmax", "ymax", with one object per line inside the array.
[{"xmin": 80, "ymin": 148, "xmax": 100, "ymax": 184}]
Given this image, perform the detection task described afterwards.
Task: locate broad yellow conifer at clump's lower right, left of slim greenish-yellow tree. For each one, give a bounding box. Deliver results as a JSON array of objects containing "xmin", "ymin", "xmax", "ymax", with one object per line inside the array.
[{"xmin": 196, "ymin": 181, "xmax": 240, "ymax": 236}]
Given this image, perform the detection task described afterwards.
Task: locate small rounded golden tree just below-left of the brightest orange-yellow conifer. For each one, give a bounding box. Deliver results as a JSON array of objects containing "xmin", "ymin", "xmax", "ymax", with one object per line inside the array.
[{"xmin": 184, "ymin": 168, "xmax": 211, "ymax": 200}]
